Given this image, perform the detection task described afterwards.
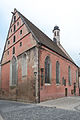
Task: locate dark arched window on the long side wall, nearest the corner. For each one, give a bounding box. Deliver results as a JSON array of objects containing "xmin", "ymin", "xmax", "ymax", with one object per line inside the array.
[{"xmin": 45, "ymin": 56, "xmax": 50, "ymax": 83}]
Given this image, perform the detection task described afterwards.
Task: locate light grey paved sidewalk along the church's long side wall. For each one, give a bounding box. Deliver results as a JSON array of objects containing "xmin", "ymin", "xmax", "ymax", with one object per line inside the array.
[{"xmin": 38, "ymin": 96, "xmax": 80, "ymax": 111}]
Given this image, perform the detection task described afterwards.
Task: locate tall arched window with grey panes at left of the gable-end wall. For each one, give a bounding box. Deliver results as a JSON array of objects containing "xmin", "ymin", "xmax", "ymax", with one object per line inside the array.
[{"xmin": 12, "ymin": 57, "xmax": 17, "ymax": 85}]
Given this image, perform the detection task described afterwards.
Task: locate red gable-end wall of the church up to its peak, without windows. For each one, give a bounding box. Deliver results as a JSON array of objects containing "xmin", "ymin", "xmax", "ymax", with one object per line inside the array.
[{"xmin": 1, "ymin": 9, "xmax": 38, "ymax": 102}]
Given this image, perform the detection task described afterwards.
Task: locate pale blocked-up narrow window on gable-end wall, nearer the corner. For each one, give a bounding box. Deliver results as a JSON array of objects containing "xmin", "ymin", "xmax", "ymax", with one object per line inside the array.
[{"xmin": 22, "ymin": 54, "xmax": 27, "ymax": 77}]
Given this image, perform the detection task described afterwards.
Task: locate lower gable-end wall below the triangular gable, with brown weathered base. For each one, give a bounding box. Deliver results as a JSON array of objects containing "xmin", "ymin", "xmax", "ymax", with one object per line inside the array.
[{"xmin": 0, "ymin": 47, "xmax": 38, "ymax": 102}]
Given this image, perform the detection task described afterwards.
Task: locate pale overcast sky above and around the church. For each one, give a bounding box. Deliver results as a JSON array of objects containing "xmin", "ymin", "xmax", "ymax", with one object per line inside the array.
[{"xmin": 0, "ymin": 0, "xmax": 80, "ymax": 66}]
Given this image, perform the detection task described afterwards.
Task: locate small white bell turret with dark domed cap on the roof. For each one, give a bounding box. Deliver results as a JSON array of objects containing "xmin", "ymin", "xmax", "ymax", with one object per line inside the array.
[{"xmin": 53, "ymin": 26, "xmax": 60, "ymax": 45}]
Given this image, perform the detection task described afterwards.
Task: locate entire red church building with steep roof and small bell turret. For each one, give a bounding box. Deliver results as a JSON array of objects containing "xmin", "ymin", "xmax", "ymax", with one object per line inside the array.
[{"xmin": 0, "ymin": 9, "xmax": 79, "ymax": 103}]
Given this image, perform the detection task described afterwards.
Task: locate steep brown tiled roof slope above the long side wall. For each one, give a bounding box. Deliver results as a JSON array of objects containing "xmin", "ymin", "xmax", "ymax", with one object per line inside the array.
[{"xmin": 18, "ymin": 12, "xmax": 77, "ymax": 66}]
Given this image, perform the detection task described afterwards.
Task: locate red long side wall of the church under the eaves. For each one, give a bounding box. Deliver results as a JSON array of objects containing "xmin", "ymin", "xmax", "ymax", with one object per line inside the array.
[{"xmin": 40, "ymin": 47, "xmax": 79, "ymax": 101}]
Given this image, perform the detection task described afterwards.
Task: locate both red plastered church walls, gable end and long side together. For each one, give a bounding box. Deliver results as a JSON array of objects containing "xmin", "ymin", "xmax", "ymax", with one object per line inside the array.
[{"xmin": 1, "ymin": 8, "xmax": 79, "ymax": 102}]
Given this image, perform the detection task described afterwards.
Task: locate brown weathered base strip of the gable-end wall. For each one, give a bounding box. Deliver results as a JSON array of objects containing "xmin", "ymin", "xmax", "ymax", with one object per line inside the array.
[{"xmin": 0, "ymin": 82, "xmax": 35, "ymax": 103}]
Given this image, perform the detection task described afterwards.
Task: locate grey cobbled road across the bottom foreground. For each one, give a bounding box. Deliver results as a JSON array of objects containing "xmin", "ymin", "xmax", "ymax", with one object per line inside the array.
[{"xmin": 0, "ymin": 97, "xmax": 80, "ymax": 120}]
